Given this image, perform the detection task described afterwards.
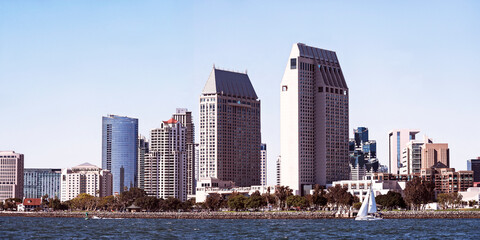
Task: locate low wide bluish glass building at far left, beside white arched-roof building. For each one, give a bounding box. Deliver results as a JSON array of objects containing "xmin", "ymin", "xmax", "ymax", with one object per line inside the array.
[{"xmin": 23, "ymin": 168, "xmax": 62, "ymax": 198}]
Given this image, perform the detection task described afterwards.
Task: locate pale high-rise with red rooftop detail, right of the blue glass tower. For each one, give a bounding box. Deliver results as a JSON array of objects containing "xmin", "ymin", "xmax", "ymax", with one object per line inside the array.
[{"xmin": 145, "ymin": 118, "xmax": 187, "ymax": 201}]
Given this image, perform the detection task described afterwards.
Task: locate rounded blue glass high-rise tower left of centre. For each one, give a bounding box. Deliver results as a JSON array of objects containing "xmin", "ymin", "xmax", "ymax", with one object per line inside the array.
[{"xmin": 102, "ymin": 115, "xmax": 138, "ymax": 195}]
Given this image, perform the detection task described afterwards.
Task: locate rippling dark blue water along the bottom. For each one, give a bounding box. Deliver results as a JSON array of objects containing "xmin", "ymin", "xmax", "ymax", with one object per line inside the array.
[{"xmin": 0, "ymin": 217, "xmax": 480, "ymax": 239}]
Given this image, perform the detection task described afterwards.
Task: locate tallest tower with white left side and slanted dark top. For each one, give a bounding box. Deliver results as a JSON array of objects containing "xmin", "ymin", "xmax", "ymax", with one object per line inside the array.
[{"xmin": 280, "ymin": 43, "xmax": 349, "ymax": 194}]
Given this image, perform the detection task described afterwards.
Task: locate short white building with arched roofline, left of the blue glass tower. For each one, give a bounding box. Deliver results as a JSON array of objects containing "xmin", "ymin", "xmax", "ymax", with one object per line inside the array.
[{"xmin": 60, "ymin": 163, "xmax": 113, "ymax": 202}]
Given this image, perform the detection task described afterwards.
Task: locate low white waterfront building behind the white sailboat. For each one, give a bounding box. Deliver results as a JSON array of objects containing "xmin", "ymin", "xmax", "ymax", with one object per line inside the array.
[{"xmin": 334, "ymin": 176, "xmax": 406, "ymax": 202}]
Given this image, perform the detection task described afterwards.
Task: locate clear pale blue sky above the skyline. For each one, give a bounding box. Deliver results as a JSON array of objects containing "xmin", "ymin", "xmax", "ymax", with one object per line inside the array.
[{"xmin": 0, "ymin": 0, "xmax": 480, "ymax": 183}]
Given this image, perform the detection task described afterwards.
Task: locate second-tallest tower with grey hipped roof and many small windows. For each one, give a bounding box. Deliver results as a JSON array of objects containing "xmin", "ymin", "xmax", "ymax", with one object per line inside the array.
[{"xmin": 199, "ymin": 68, "xmax": 261, "ymax": 187}]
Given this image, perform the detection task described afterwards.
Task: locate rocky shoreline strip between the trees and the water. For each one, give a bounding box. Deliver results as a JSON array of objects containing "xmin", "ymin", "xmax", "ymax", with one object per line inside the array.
[{"xmin": 0, "ymin": 210, "xmax": 480, "ymax": 219}]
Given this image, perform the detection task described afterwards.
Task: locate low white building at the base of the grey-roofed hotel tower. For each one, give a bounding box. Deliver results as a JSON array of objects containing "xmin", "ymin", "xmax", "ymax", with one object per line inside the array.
[{"xmin": 195, "ymin": 177, "xmax": 275, "ymax": 202}]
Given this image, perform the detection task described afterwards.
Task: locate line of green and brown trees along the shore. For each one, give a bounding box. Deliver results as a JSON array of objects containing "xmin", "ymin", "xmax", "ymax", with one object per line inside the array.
[{"xmin": 0, "ymin": 179, "xmax": 477, "ymax": 214}]
